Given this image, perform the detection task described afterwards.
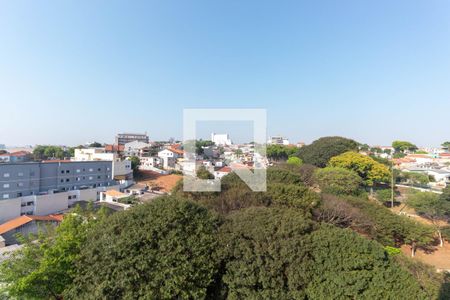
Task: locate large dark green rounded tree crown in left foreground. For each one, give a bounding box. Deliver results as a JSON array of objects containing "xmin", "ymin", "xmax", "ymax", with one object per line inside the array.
[{"xmin": 65, "ymin": 197, "xmax": 218, "ymax": 299}]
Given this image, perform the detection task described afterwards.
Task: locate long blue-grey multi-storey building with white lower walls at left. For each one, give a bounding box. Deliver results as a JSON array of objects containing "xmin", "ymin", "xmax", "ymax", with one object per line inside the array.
[{"xmin": 0, "ymin": 161, "xmax": 118, "ymax": 224}]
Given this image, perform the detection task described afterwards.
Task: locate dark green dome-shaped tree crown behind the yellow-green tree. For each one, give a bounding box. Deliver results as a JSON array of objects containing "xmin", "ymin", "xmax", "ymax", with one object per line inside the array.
[{"xmin": 297, "ymin": 136, "xmax": 358, "ymax": 168}]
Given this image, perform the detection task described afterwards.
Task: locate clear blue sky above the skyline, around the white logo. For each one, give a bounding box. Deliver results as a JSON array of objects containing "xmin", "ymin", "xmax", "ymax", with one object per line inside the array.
[{"xmin": 0, "ymin": 0, "xmax": 450, "ymax": 146}]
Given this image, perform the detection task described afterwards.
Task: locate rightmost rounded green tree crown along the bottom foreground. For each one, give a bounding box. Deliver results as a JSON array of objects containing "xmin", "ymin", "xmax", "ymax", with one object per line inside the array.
[{"xmin": 306, "ymin": 226, "xmax": 426, "ymax": 299}]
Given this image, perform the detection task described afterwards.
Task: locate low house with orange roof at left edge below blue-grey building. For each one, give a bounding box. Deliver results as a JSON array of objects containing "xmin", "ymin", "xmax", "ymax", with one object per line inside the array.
[{"xmin": 0, "ymin": 215, "xmax": 63, "ymax": 246}]
